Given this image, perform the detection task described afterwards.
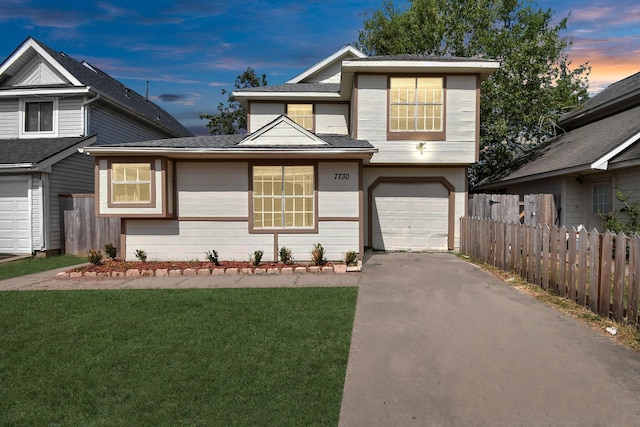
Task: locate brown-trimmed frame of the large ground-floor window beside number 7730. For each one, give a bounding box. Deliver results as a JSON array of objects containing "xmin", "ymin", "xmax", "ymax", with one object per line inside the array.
[{"xmin": 248, "ymin": 162, "xmax": 318, "ymax": 234}]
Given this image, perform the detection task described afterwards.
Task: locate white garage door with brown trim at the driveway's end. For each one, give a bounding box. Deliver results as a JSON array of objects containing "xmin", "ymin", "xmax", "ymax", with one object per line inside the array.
[{"xmin": 372, "ymin": 182, "xmax": 449, "ymax": 250}]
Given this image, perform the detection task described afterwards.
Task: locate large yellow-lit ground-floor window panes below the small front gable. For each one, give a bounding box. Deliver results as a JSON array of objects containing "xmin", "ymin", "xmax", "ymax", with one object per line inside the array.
[{"xmin": 253, "ymin": 166, "xmax": 315, "ymax": 229}]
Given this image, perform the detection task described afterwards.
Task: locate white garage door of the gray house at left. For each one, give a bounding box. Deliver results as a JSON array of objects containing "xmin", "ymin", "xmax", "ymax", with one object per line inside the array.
[{"xmin": 0, "ymin": 178, "xmax": 31, "ymax": 254}]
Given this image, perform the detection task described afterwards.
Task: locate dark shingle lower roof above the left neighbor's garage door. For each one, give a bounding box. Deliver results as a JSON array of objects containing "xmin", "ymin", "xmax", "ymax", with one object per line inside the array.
[{"xmin": 0, "ymin": 136, "xmax": 92, "ymax": 165}]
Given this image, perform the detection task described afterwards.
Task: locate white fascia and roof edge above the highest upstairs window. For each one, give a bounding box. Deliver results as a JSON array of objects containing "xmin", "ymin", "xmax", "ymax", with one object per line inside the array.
[{"xmin": 342, "ymin": 59, "xmax": 500, "ymax": 78}]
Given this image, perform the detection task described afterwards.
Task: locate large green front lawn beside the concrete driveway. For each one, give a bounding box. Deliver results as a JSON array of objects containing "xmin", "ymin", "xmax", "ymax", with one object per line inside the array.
[{"xmin": 0, "ymin": 288, "xmax": 358, "ymax": 426}]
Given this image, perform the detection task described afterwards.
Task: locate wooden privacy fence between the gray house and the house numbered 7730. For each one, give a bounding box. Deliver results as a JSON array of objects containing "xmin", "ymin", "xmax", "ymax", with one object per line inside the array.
[{"xmin": 60, "ymin": 194, "xmax": 120, "ymax": 256}]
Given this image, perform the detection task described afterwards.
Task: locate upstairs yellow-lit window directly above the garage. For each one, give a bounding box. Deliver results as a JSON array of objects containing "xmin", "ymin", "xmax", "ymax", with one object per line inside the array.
[{"xmin": 388, "ymin": 77, "xmax": 445, "ymax": 140}]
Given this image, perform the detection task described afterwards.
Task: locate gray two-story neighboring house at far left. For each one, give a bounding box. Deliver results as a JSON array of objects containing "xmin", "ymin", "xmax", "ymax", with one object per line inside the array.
[{"xmin": 0, "ymin": 38, "xmax": 192, "ymax": 254}]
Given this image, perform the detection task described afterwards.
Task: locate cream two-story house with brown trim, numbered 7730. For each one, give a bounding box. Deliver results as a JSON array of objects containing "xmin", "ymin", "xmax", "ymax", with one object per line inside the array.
[{"xmin": 83, "ymin": 46, "xmax": 499, "ymax": 261}]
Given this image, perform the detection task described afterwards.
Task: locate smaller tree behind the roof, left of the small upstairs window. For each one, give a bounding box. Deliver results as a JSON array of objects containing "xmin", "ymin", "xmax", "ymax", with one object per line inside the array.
[{"xmin": 200, "ymin": 67, "xmax": 267, "ymax": 135}]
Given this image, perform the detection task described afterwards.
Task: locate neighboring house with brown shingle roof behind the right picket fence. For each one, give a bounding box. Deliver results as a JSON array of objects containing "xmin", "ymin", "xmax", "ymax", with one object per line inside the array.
[{"xmin": 478, "ymin": 73, "xmax": 640, "ymax": 230}]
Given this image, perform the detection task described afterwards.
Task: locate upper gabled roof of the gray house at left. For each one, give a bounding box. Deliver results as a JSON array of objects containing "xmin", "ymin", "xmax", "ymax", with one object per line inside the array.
[{"xmin": 0, "ymin": 37, "xmax": 193, "ymax": 136}]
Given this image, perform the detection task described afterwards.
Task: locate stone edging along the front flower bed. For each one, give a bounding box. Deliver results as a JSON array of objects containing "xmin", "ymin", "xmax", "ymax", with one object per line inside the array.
[{"xmin": 56, "ymin": 264, "xmax": 361, "ymax": 279}]
